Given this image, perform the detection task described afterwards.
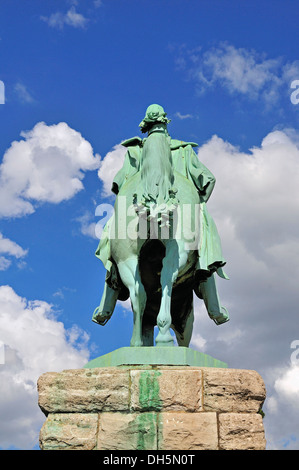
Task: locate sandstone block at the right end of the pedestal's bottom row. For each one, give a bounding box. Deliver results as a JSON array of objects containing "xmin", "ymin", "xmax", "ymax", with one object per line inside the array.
[{"xmin": 219, "ymin": 413, "xmax": 266, "ymax": 450}]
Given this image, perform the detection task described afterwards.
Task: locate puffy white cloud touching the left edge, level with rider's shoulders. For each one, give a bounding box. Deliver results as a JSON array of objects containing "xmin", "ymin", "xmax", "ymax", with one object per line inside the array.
[{"xmin": 0, "ymin": 122, "xmax": 100, "ymax": 217}]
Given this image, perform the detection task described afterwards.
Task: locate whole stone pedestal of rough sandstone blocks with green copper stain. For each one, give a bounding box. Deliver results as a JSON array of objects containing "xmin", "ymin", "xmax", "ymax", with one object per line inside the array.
[{"xmin": 38, "ymin": 352, "xmax": 266, "ymax": 451}]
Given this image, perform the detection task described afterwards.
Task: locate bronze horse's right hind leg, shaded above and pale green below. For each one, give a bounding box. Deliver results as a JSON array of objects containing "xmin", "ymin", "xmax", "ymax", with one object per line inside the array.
[{"xmin": 156, "ymin": 240, "xmax": 180, "ymax": 346}]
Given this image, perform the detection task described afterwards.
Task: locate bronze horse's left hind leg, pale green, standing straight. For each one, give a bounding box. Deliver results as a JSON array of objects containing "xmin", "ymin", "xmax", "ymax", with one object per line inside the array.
[{"xmin": 118, "ymin": 258, "xmax": 146, "ymax": 347}]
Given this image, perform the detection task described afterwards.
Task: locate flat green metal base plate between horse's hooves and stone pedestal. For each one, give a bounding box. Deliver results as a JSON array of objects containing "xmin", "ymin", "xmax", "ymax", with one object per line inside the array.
[{"xmin": 84, "ymin": 346, "xmax": 227, "ymax": 369}]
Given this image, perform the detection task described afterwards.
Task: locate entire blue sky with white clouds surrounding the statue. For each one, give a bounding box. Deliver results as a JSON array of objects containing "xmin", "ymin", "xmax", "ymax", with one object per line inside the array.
[{"xmin": 0, "ymin": 0, "xmax": 299, "ymax": 449}]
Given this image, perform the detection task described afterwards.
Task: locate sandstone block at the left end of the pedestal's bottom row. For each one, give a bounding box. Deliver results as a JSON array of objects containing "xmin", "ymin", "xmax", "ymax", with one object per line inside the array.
[{"xmin": 40, "ymin": 413, "xmax": 98, "ymax": 450}]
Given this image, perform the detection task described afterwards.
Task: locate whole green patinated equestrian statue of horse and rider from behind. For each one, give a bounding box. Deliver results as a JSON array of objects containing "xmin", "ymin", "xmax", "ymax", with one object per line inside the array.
[{"xmin": 92, "ymin": 104, "xmax": 229, "ymax": 347}]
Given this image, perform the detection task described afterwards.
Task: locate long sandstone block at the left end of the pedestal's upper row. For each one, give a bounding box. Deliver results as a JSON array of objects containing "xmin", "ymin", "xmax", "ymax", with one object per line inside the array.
[{"xmin": 38, "ymin": 368, "xmax": 130, "ymax": 415}]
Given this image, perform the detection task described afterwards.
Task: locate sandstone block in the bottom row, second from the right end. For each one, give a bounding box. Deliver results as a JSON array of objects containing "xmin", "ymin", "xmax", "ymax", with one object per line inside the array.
[{"xmin": 158, "ymin": 412, "xmax": 218, "ymax": 450}]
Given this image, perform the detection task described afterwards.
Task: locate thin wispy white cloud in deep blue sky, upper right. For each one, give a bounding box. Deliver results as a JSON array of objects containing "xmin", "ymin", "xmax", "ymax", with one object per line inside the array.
[{"xmin": 176, "ymin": 42, "xmax": 299, "ymax": 105}]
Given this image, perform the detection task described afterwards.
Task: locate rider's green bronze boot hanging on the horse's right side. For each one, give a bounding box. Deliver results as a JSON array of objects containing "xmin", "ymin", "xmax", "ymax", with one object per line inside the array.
[{"xmin": 200, "ymin": 274, "xmax": 229, "ymax": 325}]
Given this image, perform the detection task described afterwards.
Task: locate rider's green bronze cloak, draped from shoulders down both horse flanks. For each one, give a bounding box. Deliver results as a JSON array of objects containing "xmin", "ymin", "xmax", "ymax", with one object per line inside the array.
[{"xmin": 95, "ymin": 137, "xmax": 228, "ymax": 300}]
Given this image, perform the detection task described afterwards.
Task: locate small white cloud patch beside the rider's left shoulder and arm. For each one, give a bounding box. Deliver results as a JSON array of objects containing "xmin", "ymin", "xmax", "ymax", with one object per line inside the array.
[{"xmin": 98, "ymin": 144, "xmax": 127, "ymax": 197}]
